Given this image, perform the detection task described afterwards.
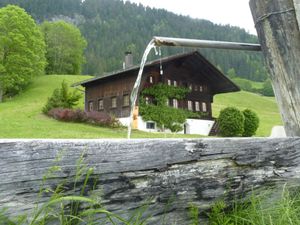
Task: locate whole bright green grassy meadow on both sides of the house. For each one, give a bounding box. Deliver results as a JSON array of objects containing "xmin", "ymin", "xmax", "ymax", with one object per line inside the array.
[{"xmin": 0, "ymin": 75, "xmax": 281, "ymax": 138}]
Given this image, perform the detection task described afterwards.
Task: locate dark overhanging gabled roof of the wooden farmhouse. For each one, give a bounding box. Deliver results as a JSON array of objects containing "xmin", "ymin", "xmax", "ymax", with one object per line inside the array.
[{"xmin": 72, "ymin": 51, "xmax": 240, "ymax": 94}]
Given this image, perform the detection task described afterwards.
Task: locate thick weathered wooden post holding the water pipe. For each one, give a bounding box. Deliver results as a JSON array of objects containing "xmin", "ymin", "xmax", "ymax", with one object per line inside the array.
[{"xmin": 250, "ymin": 0, "xmax": 300, "ymax": 136}]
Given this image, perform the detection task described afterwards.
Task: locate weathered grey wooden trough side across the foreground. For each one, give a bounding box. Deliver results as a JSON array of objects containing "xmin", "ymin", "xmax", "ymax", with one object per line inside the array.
[{"xmin": 0, "ymin": 138, "xmax": 300, "ymax": 224}]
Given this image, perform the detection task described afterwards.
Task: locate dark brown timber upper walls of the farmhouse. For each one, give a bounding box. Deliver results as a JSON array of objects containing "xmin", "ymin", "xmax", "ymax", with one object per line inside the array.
[{"xmin": 85, "ymin": 61, "xmax": 217, "ymax": 119}]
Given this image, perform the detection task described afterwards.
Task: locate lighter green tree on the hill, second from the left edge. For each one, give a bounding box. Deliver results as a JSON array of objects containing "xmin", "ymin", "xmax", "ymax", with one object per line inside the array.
[{"xmin": 41, "ymin": 21, "xmax": 87, "ymax": 74}]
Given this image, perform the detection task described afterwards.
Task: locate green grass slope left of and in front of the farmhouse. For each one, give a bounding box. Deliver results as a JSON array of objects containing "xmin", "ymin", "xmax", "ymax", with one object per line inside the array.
[{"xmin": 0, "ymin": 75, "xmax": 200, "ymax": 138}]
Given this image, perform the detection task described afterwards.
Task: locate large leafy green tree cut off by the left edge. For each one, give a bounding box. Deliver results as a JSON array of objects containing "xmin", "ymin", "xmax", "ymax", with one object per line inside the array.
[{"xmin": 0, "ymin": 5, "xmax": 46, "ymax": 98}]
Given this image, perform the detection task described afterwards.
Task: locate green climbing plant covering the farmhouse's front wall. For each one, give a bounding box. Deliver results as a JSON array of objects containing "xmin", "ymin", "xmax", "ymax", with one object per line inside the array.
[{"xmin": 139, "ymin": 83, "xmax": 200, "ymax": 132}]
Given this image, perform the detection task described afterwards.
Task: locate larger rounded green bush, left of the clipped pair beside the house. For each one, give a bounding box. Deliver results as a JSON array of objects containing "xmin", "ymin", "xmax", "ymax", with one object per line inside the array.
[{"xmin": 218, "ymin": 107, "xmax": 245, "ymax": 137}]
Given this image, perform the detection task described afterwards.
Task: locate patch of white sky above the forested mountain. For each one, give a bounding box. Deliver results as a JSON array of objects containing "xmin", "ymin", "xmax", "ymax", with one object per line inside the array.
[{"xmin": 125, "ymin": 0, "xmax": 256, "ymax": 35}]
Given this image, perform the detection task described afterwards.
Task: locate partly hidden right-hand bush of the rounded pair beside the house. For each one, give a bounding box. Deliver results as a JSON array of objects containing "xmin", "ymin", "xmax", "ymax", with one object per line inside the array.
[{"xmin": 243, "ymin": 109, "xmax": 259, "ymax": 137}]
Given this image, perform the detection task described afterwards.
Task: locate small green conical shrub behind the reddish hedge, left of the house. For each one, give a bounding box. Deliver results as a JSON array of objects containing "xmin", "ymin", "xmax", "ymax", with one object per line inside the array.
[{"xmin": 43, "ymin": 81, "xmax": 81, "ymax": 114}]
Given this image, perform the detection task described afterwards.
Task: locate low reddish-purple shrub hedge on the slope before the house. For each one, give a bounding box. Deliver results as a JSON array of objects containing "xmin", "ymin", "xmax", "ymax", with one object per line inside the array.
[{"xmin": 47, "ymin": 108, "xmax": 121, "ymax": 127}]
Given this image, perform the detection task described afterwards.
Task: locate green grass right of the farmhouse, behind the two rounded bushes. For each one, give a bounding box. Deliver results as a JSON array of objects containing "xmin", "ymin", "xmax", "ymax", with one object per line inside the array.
[{"xmin": 213, "ymin": 91, "xmax": 282, "ymax": 136}]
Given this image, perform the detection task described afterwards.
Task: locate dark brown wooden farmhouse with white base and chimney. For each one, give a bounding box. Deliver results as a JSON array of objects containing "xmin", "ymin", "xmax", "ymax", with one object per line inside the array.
[{"xmin": 77, "ymin": 51, "xmax": 240, "ymax": 135}]
